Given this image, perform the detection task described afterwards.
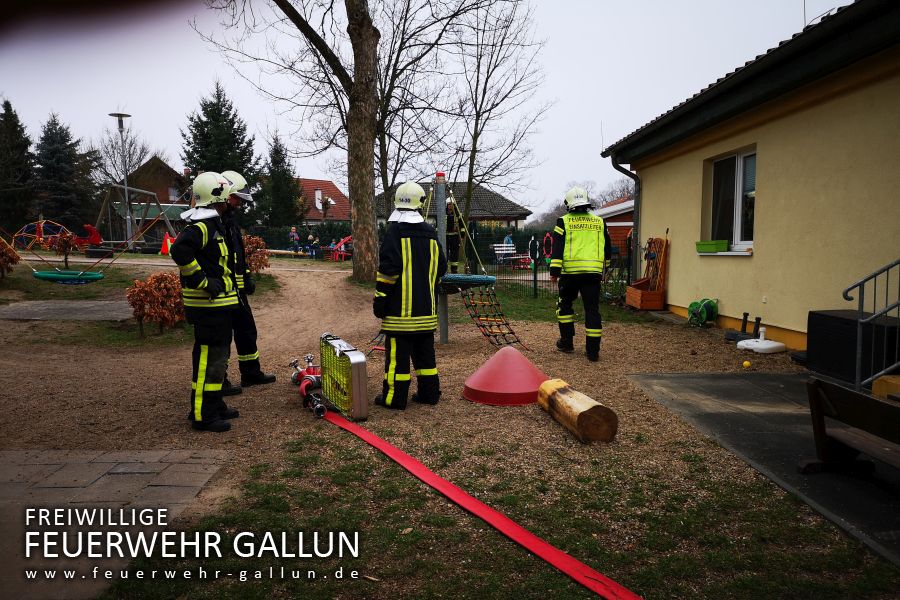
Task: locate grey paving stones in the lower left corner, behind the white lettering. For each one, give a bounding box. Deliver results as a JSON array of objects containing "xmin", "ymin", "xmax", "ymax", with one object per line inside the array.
[{"xmin": 0, "ymin": 450, "xmax": 226, "ymax": 599}]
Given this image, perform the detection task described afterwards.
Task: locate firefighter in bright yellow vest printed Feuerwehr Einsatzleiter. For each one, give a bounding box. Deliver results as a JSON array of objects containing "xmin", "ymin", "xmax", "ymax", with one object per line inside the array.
[{"xmin": 550, "ymin": 187, "xmax": 610, "ymax": 362}]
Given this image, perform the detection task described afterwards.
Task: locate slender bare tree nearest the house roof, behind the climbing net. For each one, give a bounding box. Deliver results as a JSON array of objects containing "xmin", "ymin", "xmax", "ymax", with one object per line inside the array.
[{"xmin": 449, "ymin": 0, "xmax": 549, "ymax": 251}]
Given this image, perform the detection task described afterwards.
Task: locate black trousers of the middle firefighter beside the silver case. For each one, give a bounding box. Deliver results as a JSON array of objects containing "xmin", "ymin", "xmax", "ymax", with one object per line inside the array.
[{"xmin": 381, "ymin": 331, "xmax": 441, "ymax": 409}]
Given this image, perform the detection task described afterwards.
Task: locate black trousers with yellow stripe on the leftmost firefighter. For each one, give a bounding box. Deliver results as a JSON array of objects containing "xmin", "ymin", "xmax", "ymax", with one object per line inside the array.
[{"xmin": 190, "ymin": 310, "xmax": 232, "ymax": 423}]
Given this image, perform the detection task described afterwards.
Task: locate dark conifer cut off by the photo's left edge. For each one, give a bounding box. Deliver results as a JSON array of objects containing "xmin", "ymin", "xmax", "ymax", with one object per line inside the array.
[{"xmin": 0, "ymin": 100, "xmax": 34, "ymax": 232}]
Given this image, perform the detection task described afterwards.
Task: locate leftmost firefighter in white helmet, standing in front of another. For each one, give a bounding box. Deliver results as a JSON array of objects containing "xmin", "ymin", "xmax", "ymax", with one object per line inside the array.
[{"xmin": 170, "ymin": 171, "xmax": 238, "ymax": 432}]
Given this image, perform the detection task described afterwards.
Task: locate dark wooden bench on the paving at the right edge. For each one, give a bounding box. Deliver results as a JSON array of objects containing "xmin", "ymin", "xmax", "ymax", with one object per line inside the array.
[{"xmin": 799, "ymin": 377, "xmax": 900, "ymax": 473}]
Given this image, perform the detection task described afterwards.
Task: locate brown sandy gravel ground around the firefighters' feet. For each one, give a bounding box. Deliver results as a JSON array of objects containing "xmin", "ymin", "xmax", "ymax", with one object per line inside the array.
[{"xmin": 0, "ymin": 272, "xmax": 796, "ymax": 512}]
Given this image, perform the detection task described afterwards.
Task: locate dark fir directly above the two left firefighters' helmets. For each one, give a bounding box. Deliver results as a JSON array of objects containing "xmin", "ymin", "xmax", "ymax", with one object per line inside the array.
[{"xmin": 181, "ymin": 81, "xmax": 259, "ymax": 180}]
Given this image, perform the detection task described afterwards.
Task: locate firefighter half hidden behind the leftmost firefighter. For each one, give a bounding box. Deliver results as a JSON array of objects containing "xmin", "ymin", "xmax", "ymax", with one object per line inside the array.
[{"xmin": 222, "ymin": 171, "xmax": 275, "ymax": 396}]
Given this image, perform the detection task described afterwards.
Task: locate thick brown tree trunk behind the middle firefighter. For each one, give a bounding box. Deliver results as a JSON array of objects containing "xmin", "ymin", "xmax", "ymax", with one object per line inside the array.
[{"xmin": 344, "ymin": 0, "xmax": 380, "ymax": 282}]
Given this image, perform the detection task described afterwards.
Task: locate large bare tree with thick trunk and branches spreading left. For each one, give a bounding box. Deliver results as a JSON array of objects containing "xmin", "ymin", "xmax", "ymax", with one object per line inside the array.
[{"xmin": 204, "ymin": 0, "xmax": 381, "ymax": 281}]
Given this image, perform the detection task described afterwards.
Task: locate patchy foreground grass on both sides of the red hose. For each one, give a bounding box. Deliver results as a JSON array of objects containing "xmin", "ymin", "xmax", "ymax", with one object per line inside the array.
[{"xmin": 106, "ymin": 421, "xmax": 900, "ymax": 599}]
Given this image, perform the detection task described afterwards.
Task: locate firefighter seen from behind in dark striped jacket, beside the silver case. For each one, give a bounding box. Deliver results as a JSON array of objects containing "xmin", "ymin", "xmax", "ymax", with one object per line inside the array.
[{"xmin": 372, "ymin": 181, "xmax": 447, "ymax": 410}]
